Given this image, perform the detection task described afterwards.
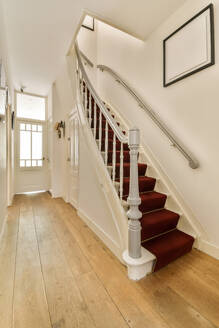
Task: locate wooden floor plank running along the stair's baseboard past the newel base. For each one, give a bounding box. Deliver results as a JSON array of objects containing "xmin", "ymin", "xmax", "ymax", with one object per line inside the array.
[{"xmin": 54, "ymin": 195, "xmax": 168, "ymax": 328}]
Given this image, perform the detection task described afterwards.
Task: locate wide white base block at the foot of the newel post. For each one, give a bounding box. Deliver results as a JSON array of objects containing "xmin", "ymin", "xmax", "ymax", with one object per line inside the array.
[{"xmin": 122, "ymin": 247, "xmax": 156, "ymax": 280}]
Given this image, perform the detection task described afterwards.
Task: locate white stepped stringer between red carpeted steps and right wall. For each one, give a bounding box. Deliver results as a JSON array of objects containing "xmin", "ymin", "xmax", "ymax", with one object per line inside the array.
[{"xmin": 104, "ymin": 99, "xmax": 206, "ymax": 249}]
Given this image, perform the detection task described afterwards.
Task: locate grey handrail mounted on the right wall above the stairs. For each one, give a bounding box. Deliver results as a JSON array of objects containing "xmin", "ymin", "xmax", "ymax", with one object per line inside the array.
[{"xmin": 97, "ymin": 65, "xmax": 199, "ymax": 169}]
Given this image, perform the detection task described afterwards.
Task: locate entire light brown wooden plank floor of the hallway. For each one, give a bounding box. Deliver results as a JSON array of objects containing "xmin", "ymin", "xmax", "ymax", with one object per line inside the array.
[{"xmin": 0, "ymin": 193, "xmax": 219, "ymax": 328}]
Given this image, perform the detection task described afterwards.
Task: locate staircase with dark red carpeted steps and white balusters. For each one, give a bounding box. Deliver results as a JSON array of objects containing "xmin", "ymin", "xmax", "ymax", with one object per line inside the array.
[{"xmin": 77, "ymin": 42, "xmax": 194, "ymax": 278}]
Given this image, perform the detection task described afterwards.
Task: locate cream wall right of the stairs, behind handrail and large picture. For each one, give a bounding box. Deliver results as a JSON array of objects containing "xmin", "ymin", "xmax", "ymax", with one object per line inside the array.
[{"xmin": 94, "ymin": 0, "xmax": 219, "ymax": 254}]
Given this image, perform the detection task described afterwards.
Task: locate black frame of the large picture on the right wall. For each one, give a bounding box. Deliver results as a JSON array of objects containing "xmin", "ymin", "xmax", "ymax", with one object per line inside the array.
[{"xmin": 163, "ymin": 3, "xmax": 215, "ymax": 87}]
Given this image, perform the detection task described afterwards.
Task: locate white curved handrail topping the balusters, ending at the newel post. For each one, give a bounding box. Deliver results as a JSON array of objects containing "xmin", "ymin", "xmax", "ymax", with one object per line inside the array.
[{"xmin": 75, "ymin": 42, "xmax": 128, "ymax": 143}]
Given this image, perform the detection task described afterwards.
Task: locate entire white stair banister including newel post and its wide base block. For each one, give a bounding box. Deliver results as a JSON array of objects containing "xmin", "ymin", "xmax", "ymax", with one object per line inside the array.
[{"xmin": 75, "ymin": 43, "xmax": 151, "ymax": 280}]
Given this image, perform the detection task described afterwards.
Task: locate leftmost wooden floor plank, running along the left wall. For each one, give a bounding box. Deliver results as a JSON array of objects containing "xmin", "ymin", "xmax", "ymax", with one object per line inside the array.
[{"xmin": 0, "ymin": 201, "xmax": 19, "ymax": 328}]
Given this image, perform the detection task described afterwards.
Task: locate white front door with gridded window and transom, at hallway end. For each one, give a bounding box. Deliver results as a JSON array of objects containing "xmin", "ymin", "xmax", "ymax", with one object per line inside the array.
[{"xmin": 15, "ymin": 94, "xmax": 50, "ymax": 193}]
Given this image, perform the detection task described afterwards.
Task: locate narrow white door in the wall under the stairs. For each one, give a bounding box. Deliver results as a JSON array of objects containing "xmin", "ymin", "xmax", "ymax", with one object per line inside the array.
[{"xmin": 68, "ymin": 115, "xmax": 79, "ymax": 208}]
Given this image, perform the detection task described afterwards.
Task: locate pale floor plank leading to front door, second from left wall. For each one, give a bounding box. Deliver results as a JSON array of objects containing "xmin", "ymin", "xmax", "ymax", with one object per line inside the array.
[{"xmin": 13, "ymin": 198, "xmax": 51, "ymax": 328}]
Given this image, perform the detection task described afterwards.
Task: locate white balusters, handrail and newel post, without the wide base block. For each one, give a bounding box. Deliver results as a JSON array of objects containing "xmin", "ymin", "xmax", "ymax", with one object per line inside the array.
[{"xmin": 77, "ymin": 50, "xmax": 142, "ymax": 266}]
